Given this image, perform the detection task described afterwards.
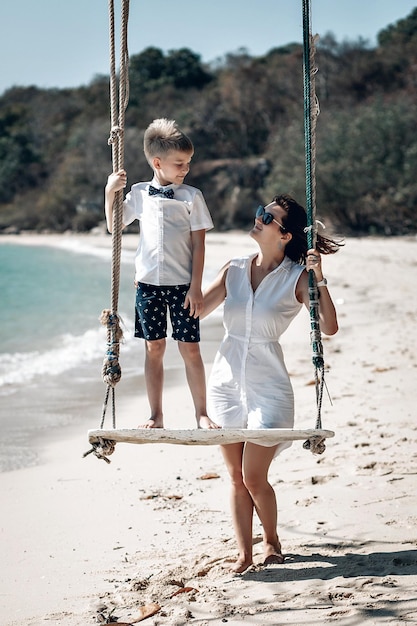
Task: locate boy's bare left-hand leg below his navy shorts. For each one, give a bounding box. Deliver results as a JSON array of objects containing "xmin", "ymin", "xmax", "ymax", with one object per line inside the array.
[{"xmin": 139, "ymin": 339, "xmax": 166, "ymax": 428}]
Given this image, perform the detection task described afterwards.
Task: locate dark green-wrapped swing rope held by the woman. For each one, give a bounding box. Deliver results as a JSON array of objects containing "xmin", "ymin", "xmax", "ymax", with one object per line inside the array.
[{"xmin": 303, "ymin": 0, "xmax": 326, "ymax": 454}]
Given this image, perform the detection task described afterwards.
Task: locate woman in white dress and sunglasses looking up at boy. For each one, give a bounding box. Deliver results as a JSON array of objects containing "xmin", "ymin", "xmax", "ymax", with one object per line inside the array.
[{"xmin": 202, "ymin": 195, "xmax": 340, "ymax": 573}]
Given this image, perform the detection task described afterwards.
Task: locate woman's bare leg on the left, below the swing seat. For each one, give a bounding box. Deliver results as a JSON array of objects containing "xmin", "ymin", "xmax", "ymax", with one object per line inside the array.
[{"xmin": 220, "ymin": 443, "xmax": 253, "ymax": 574}]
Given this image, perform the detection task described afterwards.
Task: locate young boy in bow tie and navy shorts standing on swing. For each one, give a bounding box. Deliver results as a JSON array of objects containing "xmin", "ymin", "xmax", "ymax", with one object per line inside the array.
[{"xmin": 105, "ymin": 119, "xmax": 218, "ymax": 428}]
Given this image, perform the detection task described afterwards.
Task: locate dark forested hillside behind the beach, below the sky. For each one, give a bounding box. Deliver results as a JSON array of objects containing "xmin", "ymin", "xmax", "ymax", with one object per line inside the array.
[{"xmin": 0, "ymin": 8, "xmax": 417, "ymax": 235}]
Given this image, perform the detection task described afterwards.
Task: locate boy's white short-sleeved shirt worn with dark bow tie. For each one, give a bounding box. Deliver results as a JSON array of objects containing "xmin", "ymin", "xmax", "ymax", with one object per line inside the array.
[{"xmin": 123, "ymin": 180, "xmax": 213, "ymax": 285}]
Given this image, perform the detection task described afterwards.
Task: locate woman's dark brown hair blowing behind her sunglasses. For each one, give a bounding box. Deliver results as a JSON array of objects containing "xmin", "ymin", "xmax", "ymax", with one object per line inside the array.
[{"xmin": 273, "ymin": 194, "xmax": 344, "ymax": 265}]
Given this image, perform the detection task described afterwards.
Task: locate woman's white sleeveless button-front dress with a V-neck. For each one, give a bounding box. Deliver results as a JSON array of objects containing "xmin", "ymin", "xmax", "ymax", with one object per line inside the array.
[{"xmin": 208, "ymin": 255, "xmax": 304, "ymax": 452}]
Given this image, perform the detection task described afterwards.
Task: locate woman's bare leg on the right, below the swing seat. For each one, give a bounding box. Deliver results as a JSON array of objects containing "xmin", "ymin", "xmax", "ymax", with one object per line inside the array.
[{"xmin": 242, "ymin": 443, "xmax": 284, "ymax": 565}]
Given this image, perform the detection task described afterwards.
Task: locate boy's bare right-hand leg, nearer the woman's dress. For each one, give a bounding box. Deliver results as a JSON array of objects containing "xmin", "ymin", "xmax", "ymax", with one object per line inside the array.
[{"xmin": 178, "ymin": 341, "xmax": 220, "ymax": 428}]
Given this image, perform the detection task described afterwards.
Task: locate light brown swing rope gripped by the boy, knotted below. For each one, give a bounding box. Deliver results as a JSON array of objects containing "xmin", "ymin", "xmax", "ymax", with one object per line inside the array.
[{"xmin": 84, "ymin": 0, "xmax": 129, "ymax": 463}]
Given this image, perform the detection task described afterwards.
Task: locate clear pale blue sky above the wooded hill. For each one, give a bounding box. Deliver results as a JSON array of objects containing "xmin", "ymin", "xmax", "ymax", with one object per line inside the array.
[{"xmin": 0, "ymin": 0, "xmax": 417, "ymax": 94}]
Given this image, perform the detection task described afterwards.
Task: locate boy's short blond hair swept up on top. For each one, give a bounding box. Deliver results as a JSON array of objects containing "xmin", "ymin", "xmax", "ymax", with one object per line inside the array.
[{"xmin": 143, "ymin": 117, "xmax": 194, "ymax": 165}]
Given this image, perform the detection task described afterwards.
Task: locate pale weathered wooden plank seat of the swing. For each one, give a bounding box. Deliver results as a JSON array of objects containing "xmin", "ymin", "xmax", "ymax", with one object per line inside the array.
[{"xmin": 88, "ymin": 428, "xmax": 334, "ymax": 446}]
